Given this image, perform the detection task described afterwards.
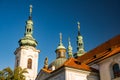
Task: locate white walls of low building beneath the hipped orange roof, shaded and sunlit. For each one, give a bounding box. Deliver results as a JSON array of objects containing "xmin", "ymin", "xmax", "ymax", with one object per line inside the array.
[{"xmin": 36, "ymin": 67, "xmax": 99, "ymax": 80}]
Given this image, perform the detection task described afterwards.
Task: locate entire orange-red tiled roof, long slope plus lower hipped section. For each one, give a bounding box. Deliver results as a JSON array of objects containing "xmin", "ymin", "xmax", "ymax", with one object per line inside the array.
[{"xmin": 42, "ymin": 35, "xmax": 120, "ymax": 73}]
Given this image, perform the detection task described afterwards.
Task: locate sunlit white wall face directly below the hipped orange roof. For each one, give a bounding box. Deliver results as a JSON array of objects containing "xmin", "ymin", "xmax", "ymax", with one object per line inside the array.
[{"xmin": 65, "ymin": 68, "xmax": 99, "ymax": 80}]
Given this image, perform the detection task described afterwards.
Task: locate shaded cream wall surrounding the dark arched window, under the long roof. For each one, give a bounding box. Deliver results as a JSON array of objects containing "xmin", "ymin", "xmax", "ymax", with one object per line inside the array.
[{"xmin": 99, "ymin": 53, "xmax": 120, "ymax": 80}]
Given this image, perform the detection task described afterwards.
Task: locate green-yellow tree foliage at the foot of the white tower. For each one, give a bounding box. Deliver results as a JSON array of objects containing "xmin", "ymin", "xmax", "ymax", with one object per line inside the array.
[{"xmin": 0, "ymin": 67, "xmax": 28, "ymax": 80}]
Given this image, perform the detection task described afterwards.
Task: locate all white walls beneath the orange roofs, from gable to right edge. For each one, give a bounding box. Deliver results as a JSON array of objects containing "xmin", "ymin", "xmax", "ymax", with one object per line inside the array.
[{"xmin": 36, "ymin": 53, "xmax": 120, "ymax": 80}]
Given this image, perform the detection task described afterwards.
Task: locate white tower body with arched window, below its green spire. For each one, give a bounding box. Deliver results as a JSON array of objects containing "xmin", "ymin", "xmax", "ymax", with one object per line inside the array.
[{"xmin": 15, "ymin": 46, "xmax": 40, "ymax": 80}]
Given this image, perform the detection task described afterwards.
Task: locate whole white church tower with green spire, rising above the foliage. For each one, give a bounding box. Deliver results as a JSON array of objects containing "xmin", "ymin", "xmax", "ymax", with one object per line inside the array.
[{"xmin": 14, "ymin": 5, "xmax": 40, "ymax": 80}]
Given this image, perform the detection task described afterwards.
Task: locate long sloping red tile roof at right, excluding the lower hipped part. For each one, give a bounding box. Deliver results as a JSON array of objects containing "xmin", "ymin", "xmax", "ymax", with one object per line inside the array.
[{"xmin": 77, "ymin": 35, "xmax": 120, "ymax": 64}]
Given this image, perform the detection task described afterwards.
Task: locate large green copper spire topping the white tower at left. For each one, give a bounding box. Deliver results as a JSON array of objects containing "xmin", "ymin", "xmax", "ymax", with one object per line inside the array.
[{"xmin": 19, "ymin": 5, "xmax": 37, "ymax": 47}]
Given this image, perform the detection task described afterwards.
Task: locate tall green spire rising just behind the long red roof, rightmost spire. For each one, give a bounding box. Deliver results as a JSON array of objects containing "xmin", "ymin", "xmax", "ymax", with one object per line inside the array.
[{"xmin": 74, "ymin": 22, "xmax": 84, "ymax": 57}]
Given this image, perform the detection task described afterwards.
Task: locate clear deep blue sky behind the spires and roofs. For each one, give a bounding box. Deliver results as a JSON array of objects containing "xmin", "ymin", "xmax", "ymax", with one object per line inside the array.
[{"xmin": 0, "ymin": 0, "xmax": 120, "ymax": 70}]
